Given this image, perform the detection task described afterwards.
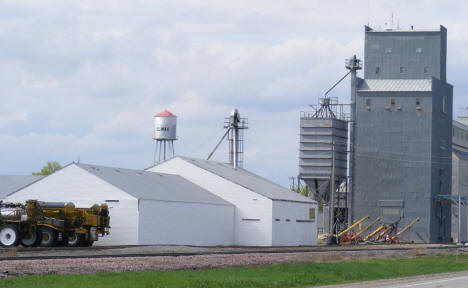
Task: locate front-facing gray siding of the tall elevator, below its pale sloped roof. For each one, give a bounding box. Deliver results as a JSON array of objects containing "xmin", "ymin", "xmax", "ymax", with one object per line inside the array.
[{"xmin": 353, "ymin": 93, "xmax": 434, "ymax": 243}]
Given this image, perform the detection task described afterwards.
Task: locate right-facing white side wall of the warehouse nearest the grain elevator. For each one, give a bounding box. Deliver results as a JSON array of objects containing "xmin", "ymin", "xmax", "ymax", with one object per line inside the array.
[{"xmin": 273, "ymin": 201, "xmax": 318, "ymax": 246}]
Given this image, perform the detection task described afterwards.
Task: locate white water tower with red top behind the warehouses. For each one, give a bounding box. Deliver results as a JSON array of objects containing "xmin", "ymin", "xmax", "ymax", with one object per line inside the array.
[{"xmin": 153, "ymin": 110, "xmax": 177, "ymax": 164}]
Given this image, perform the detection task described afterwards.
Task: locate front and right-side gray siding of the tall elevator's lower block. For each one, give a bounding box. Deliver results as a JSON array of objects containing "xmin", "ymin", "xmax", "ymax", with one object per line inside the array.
[{"xmin": 353, "ymin": 79, "xmax": 452, "ymax": 242}]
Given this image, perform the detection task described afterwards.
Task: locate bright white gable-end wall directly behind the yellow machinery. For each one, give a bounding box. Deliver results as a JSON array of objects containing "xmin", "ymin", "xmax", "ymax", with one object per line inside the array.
[{"xmin": 6, "ymin": 164, "xmax": 138, "ymax": 245}]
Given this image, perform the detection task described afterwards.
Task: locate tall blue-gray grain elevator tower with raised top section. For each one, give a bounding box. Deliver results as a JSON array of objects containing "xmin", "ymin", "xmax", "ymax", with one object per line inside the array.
[{"xmin": 352, "ymin": 26, "xmax": 453, "ymax": 243}]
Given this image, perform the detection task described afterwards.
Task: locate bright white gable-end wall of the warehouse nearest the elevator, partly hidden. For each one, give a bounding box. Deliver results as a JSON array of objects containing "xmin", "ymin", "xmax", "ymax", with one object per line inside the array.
[{"xmin": 148, "ymin": 158, "xmax": 272, "ymax": 246}]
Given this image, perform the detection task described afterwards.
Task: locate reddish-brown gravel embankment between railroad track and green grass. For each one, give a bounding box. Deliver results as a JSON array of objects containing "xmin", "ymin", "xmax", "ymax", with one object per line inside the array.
[{"xmin": 0, "ymin": 246, "xmax": 462, "ymax": 277}]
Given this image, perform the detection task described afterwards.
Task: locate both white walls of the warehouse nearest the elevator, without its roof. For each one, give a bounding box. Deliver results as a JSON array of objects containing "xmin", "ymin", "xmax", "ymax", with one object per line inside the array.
[{"xmin": 150, "ymin": 157, "xmax": 317, "ymax": 246}]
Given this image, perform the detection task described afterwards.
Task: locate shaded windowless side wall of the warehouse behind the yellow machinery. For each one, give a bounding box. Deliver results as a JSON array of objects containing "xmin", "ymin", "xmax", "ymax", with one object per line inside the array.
[{"xmin": 138, "ymin": 199, "xmax": 234, "ymax": 246}]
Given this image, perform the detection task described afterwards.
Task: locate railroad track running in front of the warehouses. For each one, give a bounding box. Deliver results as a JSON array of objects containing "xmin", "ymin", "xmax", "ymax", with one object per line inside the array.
[{"xmin": 0, "ymin": 244, "xmax": 462, "ymax": 262}]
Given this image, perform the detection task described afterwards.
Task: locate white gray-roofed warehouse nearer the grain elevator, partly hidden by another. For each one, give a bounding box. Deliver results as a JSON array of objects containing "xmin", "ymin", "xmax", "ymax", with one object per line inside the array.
[{"xmin": 148, "ymin": 156, "xmax": 317, "ymax": 246}]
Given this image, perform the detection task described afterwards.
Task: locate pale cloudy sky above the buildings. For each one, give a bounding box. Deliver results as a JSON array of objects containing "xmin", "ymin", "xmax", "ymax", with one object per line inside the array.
[{"xmin": 0, "ymin": 0, "xmax": 468, "ymax": 185}]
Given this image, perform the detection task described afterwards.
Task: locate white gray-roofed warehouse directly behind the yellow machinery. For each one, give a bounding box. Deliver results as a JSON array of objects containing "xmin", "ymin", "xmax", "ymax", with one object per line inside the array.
[{"xmin": 6, "ymin": 163, "xmax": 234, "ymax": 246}]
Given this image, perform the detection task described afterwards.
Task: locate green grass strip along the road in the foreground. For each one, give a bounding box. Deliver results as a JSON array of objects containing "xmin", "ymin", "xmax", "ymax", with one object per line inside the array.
[{"xmin": 0, "ymin": 255, "xmax": 468, "ymax": 288}]
